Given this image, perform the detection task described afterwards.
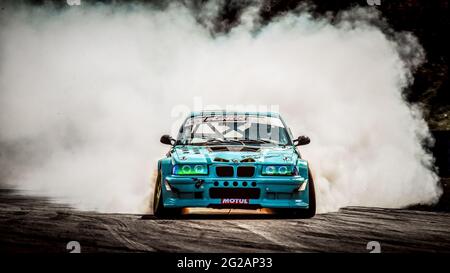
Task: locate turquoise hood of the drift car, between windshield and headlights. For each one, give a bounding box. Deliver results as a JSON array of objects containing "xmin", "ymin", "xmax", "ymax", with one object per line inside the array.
[{"xmin": 172, "ymin": 145, "xmax": 298, "ymax": 164}]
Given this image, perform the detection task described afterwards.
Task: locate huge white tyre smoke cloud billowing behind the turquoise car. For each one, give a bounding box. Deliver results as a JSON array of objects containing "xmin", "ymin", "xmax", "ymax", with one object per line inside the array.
[{"xmin": 0, "ymin": 2, "xmax": 441, "ymax": 212}]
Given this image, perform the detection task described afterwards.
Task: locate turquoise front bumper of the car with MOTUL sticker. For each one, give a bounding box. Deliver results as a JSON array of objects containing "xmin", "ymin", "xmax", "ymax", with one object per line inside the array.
[{"xmin": 162, "ymin": 175, "xmax": 309, "ymax": 209}]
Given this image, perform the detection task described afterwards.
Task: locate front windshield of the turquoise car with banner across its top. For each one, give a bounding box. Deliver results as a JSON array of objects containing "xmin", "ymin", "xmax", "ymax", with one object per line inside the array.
[{"xmin": 177, "ymin": 115, "xmax": 291, "ymax": 145}]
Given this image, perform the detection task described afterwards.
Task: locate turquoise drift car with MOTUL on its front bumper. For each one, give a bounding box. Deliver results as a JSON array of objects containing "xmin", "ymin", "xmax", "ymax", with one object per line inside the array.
[{"xmin": 153, "ymin": 111, "xmax": 316, "ymax": 218}]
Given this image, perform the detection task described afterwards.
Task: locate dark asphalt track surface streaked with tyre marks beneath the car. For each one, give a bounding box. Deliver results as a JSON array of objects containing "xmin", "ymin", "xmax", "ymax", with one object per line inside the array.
[{"xmin": 0, "ymin": 189, "xmax": 450, "ymax": 253}]
